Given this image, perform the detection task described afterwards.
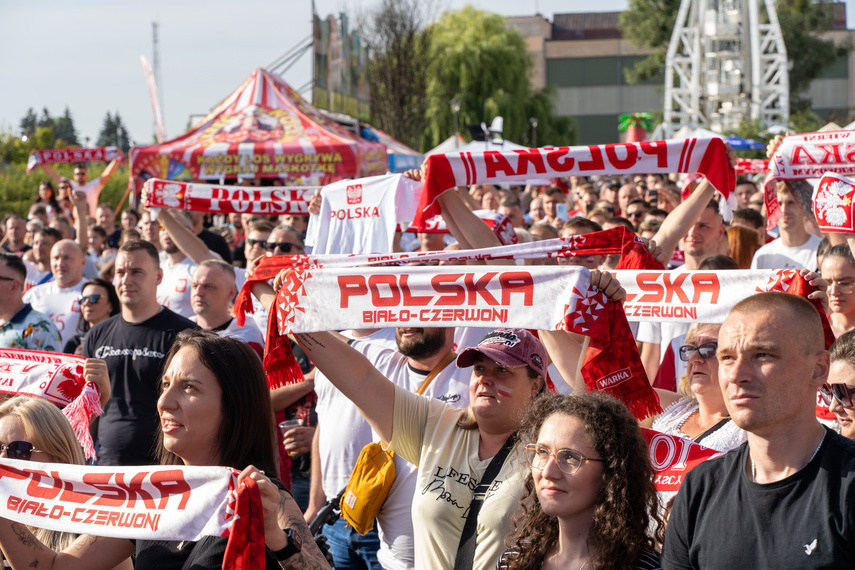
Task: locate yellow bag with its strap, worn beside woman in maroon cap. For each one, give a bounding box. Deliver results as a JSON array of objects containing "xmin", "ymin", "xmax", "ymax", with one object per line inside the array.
[{"xmin": 340, "ymin": 351, "xmax": 457, "ymax": 535}]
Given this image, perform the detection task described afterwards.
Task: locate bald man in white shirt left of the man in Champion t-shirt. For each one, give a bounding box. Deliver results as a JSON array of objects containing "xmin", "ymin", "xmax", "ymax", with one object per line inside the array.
[{"xmin": 24, "ymin": 239, "xmax": 86, "ymax": 346}]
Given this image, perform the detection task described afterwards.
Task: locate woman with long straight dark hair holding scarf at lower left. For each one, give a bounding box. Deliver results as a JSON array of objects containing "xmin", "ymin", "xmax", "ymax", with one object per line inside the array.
[{"xmin": 0, "ymin": 331, "xmax": 329, "ymax": 570}]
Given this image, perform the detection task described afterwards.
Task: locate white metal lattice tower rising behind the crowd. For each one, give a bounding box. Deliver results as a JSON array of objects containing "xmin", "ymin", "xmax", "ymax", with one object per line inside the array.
[{"xmin": 664, "ymin": 0, "xmax": 790, "ymax": 137}]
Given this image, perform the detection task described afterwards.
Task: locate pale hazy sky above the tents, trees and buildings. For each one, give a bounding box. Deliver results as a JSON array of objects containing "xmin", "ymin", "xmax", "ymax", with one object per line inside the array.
[{"xmin": 0, "ymin": 0, "xmax": 855, "ymax": 144}]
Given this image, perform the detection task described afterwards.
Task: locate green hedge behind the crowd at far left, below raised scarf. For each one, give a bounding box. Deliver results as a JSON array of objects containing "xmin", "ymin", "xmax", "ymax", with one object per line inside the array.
[{"xmin": 0, "ymin": 163, "xmax": 128, "ymax": 217}]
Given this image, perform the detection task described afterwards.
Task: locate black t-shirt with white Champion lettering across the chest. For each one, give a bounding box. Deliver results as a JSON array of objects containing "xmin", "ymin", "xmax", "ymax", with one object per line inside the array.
[{"xmin": 83, "ymin": 308, "xmax": 197, "ymax": 465}]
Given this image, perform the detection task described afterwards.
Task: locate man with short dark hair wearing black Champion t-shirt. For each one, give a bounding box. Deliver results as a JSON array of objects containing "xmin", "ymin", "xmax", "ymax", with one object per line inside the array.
[{"xmin": 83, "ymin": 240, "xmax": 196, "ymax": 465}]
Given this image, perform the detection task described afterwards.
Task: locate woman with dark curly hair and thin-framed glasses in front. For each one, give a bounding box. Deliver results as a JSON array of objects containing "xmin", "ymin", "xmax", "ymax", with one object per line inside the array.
[{"xmin": 499, "ymin": 394, "xmax": 664, "ymax": 570}]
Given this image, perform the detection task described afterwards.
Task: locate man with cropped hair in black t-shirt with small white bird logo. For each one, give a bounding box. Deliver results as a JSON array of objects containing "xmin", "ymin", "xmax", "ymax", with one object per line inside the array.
[{"xmin": 662, "ymin": 293, "xmax": 855, "ymax": 569}]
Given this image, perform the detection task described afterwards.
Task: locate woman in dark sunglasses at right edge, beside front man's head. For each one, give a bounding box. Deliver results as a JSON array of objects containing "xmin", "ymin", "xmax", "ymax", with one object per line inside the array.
[{"xmin": 819, "ymin": 331, "xmax": 855, "ymax": 439}]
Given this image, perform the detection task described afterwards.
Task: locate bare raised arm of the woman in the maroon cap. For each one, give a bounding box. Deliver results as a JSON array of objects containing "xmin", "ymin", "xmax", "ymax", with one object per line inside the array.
[{"xmin": 294, "ymin": 332, "xmax": 395, "ymax": 442}]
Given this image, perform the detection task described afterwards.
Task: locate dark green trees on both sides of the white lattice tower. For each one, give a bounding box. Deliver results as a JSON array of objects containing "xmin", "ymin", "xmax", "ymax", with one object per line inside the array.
[{"xmin": 620, "ymin": 0, "xmax": 846, "ymax": 110}]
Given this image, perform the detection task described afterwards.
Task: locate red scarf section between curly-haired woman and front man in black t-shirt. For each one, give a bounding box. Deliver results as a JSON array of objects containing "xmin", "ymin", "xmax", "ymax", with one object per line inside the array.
[{"xmin": 641, "ymin": 428, "xmax": 721, "ymax": 504}]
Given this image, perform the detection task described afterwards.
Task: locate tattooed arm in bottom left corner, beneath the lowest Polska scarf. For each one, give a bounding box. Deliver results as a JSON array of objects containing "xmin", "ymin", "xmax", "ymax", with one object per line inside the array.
[{"xmin": 0, "ymin": 519, "xmax": 134, "ymax": 570}]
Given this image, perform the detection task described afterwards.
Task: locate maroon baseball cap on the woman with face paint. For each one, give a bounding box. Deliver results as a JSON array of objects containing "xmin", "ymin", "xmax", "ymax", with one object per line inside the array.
[{"xmin": 457, "ymin": 329, "xmax": 546, "ymax": 378}]
